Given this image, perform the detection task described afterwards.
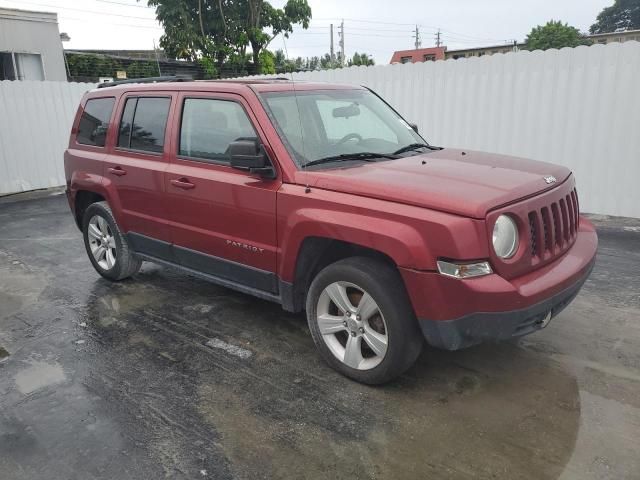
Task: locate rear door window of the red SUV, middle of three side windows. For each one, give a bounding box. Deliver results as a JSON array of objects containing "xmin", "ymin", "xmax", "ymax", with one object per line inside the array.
[{"xmin": 118, "ymin": 97, "xmax": 171, "ymax": 153}]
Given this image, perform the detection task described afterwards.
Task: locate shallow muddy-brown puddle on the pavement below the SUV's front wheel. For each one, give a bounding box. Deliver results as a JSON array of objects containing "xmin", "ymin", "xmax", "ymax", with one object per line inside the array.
[{"xmin": 198, "ymin": 346, "xmax": 580, "ymax": 480}]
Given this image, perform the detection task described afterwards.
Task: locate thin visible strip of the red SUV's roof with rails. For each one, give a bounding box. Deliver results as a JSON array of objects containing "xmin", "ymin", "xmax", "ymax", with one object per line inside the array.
[{"xmin": 91, "ymin": 77, "xmax": 363, "ymax": 95}]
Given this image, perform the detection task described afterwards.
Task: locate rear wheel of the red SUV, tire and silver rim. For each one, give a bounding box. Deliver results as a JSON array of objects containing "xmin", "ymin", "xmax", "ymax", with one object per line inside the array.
[{"xmin": 82, "ymin": 202, "xmax": 142, "ymax": 281}]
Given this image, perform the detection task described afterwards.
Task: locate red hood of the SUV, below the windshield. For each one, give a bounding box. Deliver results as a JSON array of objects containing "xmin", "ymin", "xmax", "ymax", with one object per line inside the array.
[{"xmin": 296, "ymin": 149, "xmax": 571, "ymax": 218}]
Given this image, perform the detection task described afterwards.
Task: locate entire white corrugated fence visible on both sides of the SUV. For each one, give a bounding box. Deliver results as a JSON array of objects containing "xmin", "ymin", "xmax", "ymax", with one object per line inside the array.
[{"xmin": 0, "ymin": 42, "xmax": 640, "ymax": 218}]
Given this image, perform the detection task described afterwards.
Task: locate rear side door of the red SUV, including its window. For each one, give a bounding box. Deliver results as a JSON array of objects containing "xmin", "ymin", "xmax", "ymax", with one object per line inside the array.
[{"xmin": 104, "ymin": 92, "xmax": 172, "ymax": 258}]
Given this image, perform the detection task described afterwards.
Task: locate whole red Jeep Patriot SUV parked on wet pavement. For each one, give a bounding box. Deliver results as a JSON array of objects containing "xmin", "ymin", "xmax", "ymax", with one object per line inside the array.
[{"xmin": 64, "ymin": 79, "xmax": 598, "ymax": 384}]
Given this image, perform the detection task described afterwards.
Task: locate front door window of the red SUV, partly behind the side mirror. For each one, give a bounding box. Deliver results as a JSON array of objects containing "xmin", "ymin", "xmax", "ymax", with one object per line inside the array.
[{"xmin": 179, "ymin": 98, "xmax": 257, "ymax": 162}]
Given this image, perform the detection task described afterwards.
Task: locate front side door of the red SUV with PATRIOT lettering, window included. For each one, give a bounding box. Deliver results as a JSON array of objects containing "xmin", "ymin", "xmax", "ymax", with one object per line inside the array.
[{"xmin": 166, "ymin": 93, "xmax": 281, "ymax": 293}]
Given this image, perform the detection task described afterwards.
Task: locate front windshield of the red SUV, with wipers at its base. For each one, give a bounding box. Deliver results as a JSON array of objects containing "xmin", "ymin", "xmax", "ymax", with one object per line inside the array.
[{"xmin": 261, "ymin": 89, "xmax": 425, "ymax": 167}]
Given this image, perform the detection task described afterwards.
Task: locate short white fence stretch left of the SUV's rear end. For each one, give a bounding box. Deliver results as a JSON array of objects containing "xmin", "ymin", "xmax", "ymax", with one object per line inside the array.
[{"xmin": 0, "ymin": 81, "xmax": 94, "ymax": 195}]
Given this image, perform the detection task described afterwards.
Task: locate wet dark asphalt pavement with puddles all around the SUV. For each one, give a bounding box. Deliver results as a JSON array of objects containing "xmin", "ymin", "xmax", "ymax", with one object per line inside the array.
[{"xmin": 0, "ymin": 194, "xmax": 640, "ymax": 480}]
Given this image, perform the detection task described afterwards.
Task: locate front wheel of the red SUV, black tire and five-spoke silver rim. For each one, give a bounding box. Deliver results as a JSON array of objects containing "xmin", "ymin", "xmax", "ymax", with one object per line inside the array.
[{"xmin": 306, "ymin": 257, "xmax": 424, "ymax": 385}]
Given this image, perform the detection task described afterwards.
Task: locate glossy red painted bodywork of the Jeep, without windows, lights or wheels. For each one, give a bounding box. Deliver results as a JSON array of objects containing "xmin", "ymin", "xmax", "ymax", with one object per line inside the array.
[{"xmin": 65, "ymin": 82, "xmax": 597, "ymax": 344}]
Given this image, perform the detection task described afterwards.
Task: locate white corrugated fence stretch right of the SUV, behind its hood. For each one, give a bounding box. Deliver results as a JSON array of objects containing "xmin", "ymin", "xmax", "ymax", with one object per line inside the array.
[{"xmin": 254, "ymin": 42, "xmax": 640, "ymax": 217}]
